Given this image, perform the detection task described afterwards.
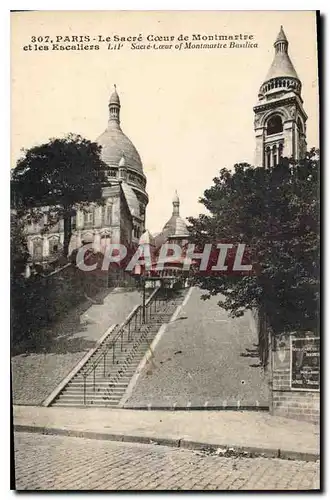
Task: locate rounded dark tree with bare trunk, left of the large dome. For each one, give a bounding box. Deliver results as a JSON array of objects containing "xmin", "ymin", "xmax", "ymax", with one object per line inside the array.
[{"xmin": 11, "ymin": 134, "xmax": 107, "ymax": 257}]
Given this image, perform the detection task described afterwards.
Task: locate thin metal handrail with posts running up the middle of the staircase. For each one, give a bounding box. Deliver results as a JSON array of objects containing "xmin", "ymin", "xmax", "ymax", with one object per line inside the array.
[{"xmin": 82, "ymin": 287, "xmax": 161, "ymax": 404}]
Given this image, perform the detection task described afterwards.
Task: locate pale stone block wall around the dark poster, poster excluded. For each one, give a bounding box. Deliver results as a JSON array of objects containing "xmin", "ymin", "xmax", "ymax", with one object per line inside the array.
[{"xmin": 270, "ymin": 335, "xmax": 320, "ymax": 423}]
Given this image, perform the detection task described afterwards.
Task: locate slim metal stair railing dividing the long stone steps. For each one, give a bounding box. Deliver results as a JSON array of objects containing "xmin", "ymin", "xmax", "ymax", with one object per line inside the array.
[{"xmin": 82, "ymin": 287, "xmax": 163, "ymax": 405}]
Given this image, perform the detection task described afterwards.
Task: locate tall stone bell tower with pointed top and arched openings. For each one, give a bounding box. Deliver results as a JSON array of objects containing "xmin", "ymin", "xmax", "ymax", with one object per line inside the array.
[{"xmin": 253, "ymin": 26, "xmax": 307, "ymax": 168}]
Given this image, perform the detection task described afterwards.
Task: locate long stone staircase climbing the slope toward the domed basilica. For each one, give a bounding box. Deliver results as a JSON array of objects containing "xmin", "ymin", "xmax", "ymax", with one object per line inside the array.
[{"xmin": 51, "ymin": 290, "xmax": 186, "ymax": 407}]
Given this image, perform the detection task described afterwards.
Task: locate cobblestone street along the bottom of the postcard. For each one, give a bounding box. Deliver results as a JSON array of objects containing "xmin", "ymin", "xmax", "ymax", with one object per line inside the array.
[{"xmin": 15, "ymin": 432, "xmax": 319, "ymax": 490}]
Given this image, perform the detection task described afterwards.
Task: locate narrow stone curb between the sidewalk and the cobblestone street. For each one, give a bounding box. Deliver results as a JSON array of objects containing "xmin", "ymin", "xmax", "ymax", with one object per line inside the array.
[{"xmin": 14, "ymin": 424, "xmax": 320, "ymax": 462}]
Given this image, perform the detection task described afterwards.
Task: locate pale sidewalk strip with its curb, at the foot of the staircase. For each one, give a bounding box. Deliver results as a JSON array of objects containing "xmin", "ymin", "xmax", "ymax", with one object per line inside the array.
[{"xmin": 13, "ymin": 406, "xmax": 319, "ymax": 460}]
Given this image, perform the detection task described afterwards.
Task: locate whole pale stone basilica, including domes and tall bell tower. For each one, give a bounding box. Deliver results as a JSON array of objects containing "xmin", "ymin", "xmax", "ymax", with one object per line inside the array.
[{"xmin": 24, "ymin": 27, "xmax": 307, "ymax": 262}]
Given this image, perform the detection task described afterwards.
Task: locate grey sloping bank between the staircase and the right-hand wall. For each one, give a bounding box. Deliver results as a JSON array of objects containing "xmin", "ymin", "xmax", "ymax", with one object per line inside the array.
[{"xmin": 126, "ymin": 287, "xmax": 269, "ymax": 408}]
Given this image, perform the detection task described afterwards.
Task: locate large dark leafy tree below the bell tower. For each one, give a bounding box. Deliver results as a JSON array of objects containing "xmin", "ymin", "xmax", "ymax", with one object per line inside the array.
[{"xmin": 190, "ymin": 149, "xmax": 319, "ymax": 364}]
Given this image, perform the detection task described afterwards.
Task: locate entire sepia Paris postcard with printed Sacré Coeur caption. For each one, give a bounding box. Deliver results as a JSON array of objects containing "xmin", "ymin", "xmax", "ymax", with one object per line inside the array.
[{"xmin": 8, "ymin": 10, "xmax": 321, "ymax": 491}]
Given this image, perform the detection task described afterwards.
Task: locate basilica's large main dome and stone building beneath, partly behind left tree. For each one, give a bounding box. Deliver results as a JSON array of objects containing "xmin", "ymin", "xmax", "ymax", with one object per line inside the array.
[{"xmin": 27, "ymin": 88, "xmax": 149, "ymax": 263}]
